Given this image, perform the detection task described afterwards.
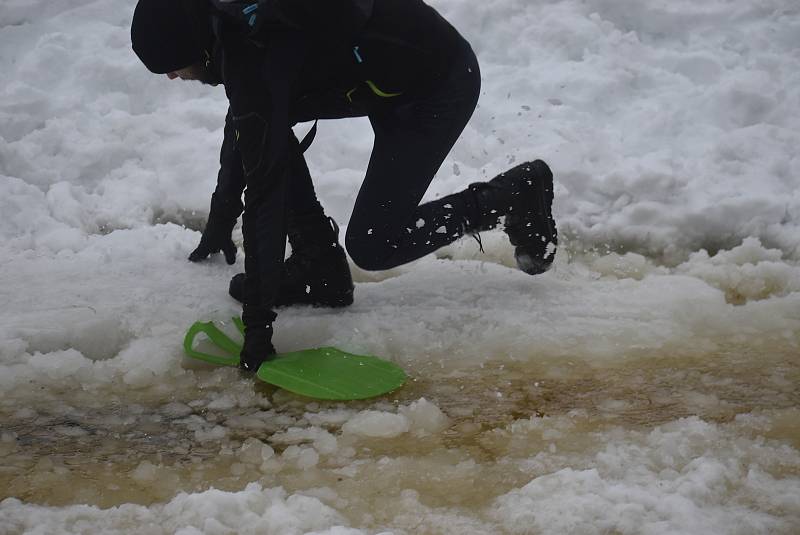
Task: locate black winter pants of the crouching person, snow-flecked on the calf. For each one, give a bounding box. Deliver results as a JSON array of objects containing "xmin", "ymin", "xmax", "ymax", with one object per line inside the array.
[{"xmin": 289, "ymin": 47, "xmax": 480, "ymax": 270}]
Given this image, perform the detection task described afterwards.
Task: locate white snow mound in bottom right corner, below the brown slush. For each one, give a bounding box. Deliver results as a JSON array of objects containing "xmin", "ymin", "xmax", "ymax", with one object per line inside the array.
[{"xmin": 495, "ymin": 419, "xmax": 800, "ymax": 534}]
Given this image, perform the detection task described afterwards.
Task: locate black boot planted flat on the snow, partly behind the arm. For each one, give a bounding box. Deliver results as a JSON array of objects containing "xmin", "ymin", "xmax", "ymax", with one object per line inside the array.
[{"xmin": 228, "ymin": 217, "xmax": 353, "ymax": 308}]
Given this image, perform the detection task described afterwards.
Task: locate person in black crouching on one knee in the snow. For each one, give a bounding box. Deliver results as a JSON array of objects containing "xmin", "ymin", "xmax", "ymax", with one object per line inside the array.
[{"xmin": 131, "ymin": 0, "xmax": 557, "ymax": 370}]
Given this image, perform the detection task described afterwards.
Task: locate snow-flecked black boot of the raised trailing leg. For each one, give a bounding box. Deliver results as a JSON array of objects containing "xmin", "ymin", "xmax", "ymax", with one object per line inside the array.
[{"xmin": 465, "ymin": 160, "xmax": 558, "ymax": 275}]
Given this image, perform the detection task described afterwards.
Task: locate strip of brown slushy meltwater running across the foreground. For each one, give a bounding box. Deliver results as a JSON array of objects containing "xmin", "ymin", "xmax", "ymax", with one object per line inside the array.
[{"xmin": 0, "ymin": 348, "xmax": 800, "ymax": 532}]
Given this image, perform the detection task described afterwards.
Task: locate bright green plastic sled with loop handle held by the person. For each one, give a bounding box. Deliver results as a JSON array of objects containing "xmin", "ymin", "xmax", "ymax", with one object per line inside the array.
[{"xmin": 183, "ymin": 318, "xmax": 406, "ymax": 401}]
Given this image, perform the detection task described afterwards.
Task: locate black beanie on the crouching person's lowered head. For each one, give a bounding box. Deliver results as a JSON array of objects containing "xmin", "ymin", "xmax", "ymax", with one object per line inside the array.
[{"xmin": 131, "ymin": 0, "xmax": 211, "ymax": 74}]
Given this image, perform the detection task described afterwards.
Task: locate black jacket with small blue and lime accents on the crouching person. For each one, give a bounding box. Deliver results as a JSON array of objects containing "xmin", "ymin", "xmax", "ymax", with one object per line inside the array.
[{"xmin": 209, "ymin": 0, "xmax": 469, "ymax": 325}]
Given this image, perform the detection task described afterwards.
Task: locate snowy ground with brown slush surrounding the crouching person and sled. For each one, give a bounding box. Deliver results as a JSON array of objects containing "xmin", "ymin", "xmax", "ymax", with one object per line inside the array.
[{"xmin": 0, "ymin": 0, "xmax": 800, "ymax": 535}]
